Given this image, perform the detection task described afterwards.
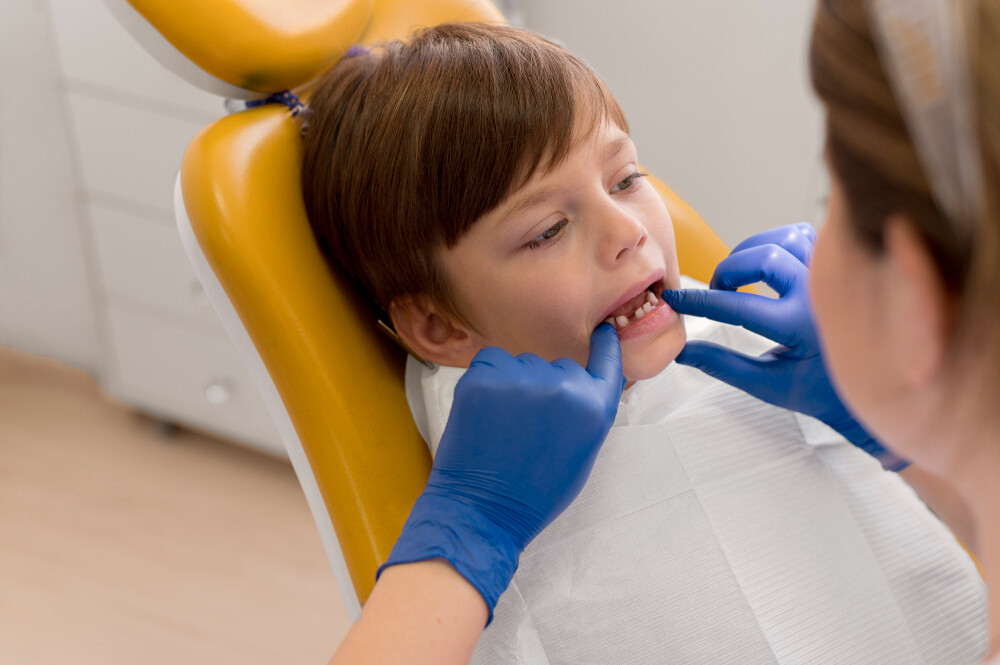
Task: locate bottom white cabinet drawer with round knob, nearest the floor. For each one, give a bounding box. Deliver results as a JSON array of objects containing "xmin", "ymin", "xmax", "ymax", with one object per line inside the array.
[{"xmin": 106, "ymin": 307, "xmax": 284, "ymax": 454}]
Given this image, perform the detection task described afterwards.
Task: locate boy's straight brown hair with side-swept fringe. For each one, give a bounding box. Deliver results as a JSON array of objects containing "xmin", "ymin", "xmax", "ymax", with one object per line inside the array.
[{"xmin": 302, "ymin": 23, "xmax": 628, "ymax": 318}]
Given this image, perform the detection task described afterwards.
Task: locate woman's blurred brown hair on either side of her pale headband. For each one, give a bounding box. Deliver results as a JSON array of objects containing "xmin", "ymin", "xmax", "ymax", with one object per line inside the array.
[{"xmin": 810, "ymin": 0, "xmax": 1000, "ymax": 409}]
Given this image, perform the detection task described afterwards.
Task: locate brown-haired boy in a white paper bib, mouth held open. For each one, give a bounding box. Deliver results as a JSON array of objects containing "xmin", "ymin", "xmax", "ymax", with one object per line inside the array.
[{"xmin": 303, "ymin": 24, "xmax": 986, "ymax": 664}]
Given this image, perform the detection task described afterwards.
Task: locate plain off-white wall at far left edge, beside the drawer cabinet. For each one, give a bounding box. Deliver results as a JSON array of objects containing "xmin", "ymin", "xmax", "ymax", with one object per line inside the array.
[{"xmin": 0, "ymin": 0, "xmax": 101, "ymax": 369}]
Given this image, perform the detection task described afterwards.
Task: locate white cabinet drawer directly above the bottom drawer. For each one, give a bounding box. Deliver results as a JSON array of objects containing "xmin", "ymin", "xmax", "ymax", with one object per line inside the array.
[{"xmin": 89, "ymin": 205, "xmax": 225, "ymax": 326}]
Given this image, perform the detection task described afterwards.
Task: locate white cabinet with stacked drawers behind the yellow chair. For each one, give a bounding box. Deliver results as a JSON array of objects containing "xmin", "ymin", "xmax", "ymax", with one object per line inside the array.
[{"xmin": 15, "ymin": 0, "xmax": 283, "ymax": 453}]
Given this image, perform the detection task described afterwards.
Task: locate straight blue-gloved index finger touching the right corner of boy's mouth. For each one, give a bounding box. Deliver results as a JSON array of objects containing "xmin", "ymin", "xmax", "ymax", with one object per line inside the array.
[{"xmin": 662, "ymin": 289, "xmax": 795, "ymax": 346}]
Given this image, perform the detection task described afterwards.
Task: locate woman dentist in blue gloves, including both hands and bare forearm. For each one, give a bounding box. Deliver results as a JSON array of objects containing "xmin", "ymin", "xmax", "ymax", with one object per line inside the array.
[{"xmin": 332, "ymin": 0, "xmax": 1000, "ymax": 665}]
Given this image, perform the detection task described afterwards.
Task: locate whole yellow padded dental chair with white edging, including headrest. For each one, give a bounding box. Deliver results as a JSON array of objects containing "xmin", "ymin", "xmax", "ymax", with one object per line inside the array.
[{"xmin": 104, "ymin": 0, "xmax": 728, "ymax": 619}]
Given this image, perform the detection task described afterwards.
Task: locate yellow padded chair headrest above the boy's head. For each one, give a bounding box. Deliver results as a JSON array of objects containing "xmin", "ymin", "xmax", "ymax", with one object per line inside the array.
[{"xmin": 104, "ymin": 0, "xmax": 503, "ymax": 99}]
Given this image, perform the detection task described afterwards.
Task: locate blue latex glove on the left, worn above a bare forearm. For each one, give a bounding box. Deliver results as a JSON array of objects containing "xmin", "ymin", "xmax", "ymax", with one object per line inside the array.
[{"xmin": 379, "ymin": 323, "xmax": 625, "ymax": 620}]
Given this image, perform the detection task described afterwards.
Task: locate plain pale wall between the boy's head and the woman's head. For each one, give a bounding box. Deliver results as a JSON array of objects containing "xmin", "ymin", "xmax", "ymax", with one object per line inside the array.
[{"xmin": 520, "ymin": 0, "xmax": 826, "ymax": 245}]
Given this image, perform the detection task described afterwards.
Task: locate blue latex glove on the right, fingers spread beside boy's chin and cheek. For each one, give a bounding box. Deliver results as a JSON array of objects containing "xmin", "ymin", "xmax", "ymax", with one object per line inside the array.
[{"xmin": 663, "ymin": 224, "xmax": 909, "ymax": 471}]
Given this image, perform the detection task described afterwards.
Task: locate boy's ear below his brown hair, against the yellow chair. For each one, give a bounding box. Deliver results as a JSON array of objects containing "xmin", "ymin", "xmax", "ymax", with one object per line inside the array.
[{"xmin": 388, "ymin": 293, "xmax": 480, "ymax": 367}]
